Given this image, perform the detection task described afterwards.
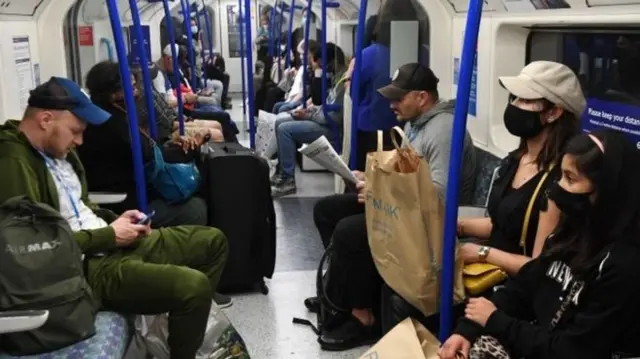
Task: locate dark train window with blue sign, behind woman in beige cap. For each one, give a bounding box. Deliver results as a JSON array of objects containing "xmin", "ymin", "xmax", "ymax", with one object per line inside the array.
[{"xmin": 527, "ymin": 28, "xmax": 640, "ymax": 148}]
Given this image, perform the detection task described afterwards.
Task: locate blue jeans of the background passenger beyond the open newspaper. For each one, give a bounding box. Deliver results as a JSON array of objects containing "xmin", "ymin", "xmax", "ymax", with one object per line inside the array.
[{"xmin": 276, "ymin": 120, "xmax": 331, "ymax": 177}]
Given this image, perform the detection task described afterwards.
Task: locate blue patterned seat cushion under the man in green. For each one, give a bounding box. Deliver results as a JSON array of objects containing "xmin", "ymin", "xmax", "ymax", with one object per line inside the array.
[{"xmin": 0, "ymin": 312, "xmax": 133, "ymax": 359}]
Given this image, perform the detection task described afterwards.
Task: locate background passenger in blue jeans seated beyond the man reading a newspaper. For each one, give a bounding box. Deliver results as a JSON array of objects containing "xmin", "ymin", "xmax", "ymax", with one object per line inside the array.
[{"xmin": 271, "ymin": 44, "xmax": 346, "ymax": 197}]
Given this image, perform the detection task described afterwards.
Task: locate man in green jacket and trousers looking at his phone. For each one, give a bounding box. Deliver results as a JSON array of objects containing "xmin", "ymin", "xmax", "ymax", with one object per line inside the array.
[{"xmin": 0, "ymin": 77, "xmax": 228, "ymax": 359}]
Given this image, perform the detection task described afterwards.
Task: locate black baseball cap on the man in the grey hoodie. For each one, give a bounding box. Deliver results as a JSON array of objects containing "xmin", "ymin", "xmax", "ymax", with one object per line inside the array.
[{"xmin": 378, "ymin": 62, "xmax": 440, "ymax": 101}]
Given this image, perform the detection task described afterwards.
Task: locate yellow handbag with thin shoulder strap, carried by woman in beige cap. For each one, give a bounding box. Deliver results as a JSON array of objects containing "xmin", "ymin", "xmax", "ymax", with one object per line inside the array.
[{"xmin": 463, "ymin": 165, "xmax": 553, "ymax": 296}]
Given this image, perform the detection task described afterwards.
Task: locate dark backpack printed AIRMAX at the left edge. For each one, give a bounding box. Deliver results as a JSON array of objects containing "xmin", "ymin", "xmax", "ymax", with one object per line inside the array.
[{"xmin": 0, "ymin": 197, "xmax": 98, "ymax": 356}]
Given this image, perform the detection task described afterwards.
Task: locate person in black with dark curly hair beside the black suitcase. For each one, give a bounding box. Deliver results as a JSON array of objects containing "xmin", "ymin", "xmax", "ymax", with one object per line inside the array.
[{"xmin": 78, "ymin": 61, "xmax": 207, "ymax": 228}]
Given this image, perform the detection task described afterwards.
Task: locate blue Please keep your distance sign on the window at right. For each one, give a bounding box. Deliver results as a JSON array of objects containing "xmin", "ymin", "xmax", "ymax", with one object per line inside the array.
[{"xmin": 582, "ymin": 98, "xmax": 640, "ymax": 149}]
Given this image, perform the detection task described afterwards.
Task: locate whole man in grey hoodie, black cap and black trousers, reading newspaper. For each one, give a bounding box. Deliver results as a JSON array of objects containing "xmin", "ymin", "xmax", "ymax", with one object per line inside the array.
[{"xmin": 305, "ymin": 63, "xmax": 476, "ymax": 350}]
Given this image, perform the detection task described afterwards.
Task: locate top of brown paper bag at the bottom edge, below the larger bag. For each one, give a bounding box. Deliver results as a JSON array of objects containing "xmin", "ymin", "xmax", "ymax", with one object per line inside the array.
[{"xmin": 360, "ymin": 318, "xmax": 440, "ymax": 359}]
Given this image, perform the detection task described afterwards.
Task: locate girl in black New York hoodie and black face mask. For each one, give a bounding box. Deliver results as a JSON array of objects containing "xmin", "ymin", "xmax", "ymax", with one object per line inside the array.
[{"xmin": 439, "ymin": 130, "xmax": 640, "ymax": 359}]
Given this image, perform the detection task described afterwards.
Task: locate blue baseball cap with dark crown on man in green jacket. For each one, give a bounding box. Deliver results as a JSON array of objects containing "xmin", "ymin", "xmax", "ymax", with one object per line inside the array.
[{"xmin": 29, "ymin": 77, "xmax": 111, "ymax": 125}]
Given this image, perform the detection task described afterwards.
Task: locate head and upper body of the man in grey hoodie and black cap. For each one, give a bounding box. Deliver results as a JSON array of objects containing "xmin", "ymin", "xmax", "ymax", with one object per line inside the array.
[{"xmin": 378, "ymin": 63, "xmax": 476, "ymax": 205}]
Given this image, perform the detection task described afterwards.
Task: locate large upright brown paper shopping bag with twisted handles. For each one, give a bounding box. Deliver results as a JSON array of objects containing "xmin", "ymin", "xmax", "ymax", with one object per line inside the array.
[{"xmin": 365, "ymin": 127, "xmax": 464, "ymax": 315}]
